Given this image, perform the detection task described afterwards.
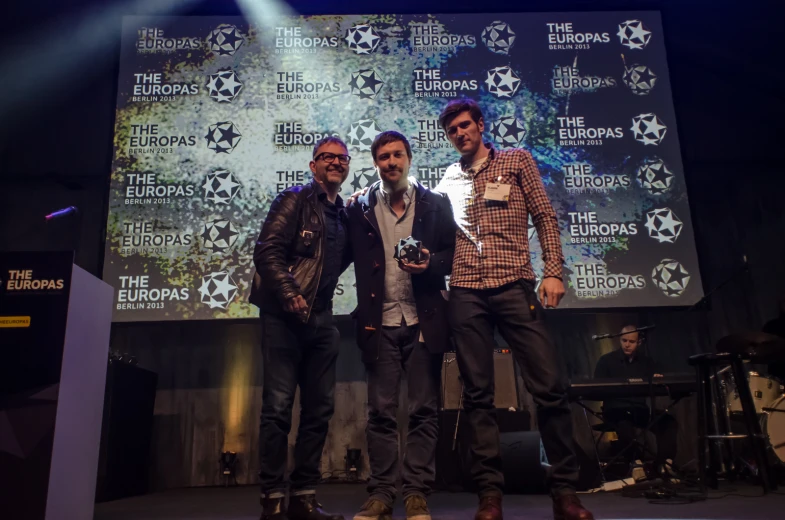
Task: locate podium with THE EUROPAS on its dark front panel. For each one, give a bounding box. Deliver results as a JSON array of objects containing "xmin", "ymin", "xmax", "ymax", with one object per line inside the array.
[{"xmin": 0, "ymin": 251, "xmax": 113, "ymax": 520}]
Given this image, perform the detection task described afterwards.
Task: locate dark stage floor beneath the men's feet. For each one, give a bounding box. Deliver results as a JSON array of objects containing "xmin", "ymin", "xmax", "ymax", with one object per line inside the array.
[{"xmin": 94, "ymin": 484, "xmax": 785, "ymax": 520}]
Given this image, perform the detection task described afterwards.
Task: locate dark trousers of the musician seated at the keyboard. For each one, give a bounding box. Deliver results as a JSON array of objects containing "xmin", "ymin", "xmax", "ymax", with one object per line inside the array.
[{"xmin": 602, "ymin": 407, "xmax": 679, "ymax": 466}]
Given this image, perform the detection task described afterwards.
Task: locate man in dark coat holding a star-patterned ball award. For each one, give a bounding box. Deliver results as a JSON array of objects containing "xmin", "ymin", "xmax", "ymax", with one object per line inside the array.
[{"xmin": 347, "ymin": 131, "xmax": 456, "ymax": 520}]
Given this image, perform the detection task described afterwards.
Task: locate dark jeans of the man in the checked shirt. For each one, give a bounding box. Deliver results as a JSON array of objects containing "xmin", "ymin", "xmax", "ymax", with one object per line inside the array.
[{"xmin": 450, "ymin": 280, "xmax": 578, "ymax": 496}]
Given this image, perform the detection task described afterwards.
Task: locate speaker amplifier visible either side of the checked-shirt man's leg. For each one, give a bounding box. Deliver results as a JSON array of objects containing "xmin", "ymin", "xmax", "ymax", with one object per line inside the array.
[{"xmin": 442, "ymin": 351, "xmax": 520, "ymax": 410}]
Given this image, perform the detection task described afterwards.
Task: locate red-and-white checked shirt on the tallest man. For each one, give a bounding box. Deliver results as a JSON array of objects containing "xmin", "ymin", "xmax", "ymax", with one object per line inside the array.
[{"xmin": 435, "ymin": 145, "xmax": 564, "ymax": 289}]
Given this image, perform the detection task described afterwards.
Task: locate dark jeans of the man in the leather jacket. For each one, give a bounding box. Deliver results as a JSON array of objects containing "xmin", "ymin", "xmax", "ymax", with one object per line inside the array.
[{"xmin": 259, "ymin": 309, "xmax": 339, "ymax": 498}]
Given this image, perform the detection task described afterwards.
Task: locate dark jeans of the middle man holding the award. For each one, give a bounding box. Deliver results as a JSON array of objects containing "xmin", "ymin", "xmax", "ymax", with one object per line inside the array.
[{"xmin": 366, "ymin": 325, "xmax": 442, "ymax": 506}]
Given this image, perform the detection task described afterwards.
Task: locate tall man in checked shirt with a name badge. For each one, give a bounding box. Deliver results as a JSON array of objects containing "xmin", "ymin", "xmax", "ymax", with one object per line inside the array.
[{"xmin": 435, "ymin": 99, "xmax": 594, "ymax": 520}]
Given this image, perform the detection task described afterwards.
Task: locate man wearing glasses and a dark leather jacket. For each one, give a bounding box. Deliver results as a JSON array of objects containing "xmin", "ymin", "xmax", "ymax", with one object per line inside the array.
[{"xmin": 249, "ymin": 137, "xmax": 351, "ymax": 520}]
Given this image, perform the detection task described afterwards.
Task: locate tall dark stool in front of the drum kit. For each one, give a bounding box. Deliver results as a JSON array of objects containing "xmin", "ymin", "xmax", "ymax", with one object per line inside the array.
[{"xmin": 689, "ymin": 352, "xmax": 777, "ymax": 493}]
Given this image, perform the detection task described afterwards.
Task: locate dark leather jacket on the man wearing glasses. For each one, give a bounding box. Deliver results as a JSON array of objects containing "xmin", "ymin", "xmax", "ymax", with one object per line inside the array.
[{"xmin": 248, "ymin": 180, "xmax": 334, "ymax": 323}]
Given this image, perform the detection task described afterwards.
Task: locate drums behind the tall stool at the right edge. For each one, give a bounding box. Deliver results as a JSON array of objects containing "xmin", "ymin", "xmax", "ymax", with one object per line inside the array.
[{"xmin": 715, "ymin": 367, "xmax": 785, "ymax": 467}]
